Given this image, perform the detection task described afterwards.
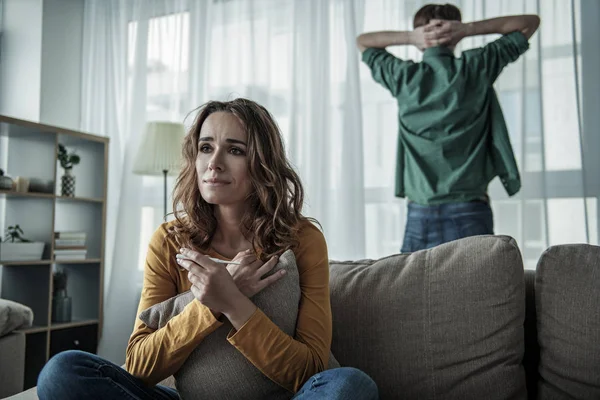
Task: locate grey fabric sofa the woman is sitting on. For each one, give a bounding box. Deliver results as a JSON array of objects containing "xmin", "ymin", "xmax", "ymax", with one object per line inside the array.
[{"xmin": 5, "ymin": 236, "xmax": 600, "ymax": 400}]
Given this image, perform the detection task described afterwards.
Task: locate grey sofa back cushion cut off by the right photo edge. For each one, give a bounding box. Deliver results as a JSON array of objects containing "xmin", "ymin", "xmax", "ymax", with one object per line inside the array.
[{"xmin": 535, "ymin": 245, "xmax": 600, "ymax": 399}]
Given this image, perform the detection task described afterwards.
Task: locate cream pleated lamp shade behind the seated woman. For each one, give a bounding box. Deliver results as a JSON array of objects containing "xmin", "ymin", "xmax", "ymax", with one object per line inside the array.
[{"xmin": 133, "ymin": 121, "xmax": 185, "ymax": 175}]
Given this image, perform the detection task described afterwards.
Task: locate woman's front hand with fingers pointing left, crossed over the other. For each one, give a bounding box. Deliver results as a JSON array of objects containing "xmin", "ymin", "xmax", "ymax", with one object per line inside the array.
[{"xmin": 177, "ymin": 249, "xmax": 245, "ymax": 316}]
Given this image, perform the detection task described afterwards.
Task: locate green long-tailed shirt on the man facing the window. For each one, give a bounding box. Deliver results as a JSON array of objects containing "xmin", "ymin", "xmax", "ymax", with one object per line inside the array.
[{"xmin": 363, "ymin": 32, "xmax": 529, "ymax": 204}]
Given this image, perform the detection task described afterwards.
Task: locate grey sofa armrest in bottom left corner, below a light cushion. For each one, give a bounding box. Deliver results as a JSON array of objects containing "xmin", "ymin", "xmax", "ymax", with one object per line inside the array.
[{"xmin": 0, "ymin": 332, "xmax": 25, "ymax": 398}]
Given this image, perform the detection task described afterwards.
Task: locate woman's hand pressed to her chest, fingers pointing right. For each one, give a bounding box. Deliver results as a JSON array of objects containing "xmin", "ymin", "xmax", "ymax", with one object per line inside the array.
[{"xmin": 227, "ymin": 250, "xmax": 285, "ymax": 298}]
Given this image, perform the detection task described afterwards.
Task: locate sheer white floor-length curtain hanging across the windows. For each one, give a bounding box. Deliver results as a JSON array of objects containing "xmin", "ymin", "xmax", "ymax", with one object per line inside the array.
[{"xmin": 82, "ymin": 0, "xmax": 597, "ymax": 362}]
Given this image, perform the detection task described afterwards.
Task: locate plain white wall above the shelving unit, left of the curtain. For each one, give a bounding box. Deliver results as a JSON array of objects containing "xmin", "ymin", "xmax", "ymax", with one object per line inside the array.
[{"xmin": 0, "ymin": 0, "xmax": 84, "ymax": 129}]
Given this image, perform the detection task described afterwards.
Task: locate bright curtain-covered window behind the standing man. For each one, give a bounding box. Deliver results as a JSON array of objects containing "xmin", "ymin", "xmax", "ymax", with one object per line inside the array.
[{"xmin": 361, "ymin": 0, "xmax": 597, "ymax": 262}]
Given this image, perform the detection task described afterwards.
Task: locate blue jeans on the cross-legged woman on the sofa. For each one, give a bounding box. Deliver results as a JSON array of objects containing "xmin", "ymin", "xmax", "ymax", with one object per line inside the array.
[{"xmin": 37, "ymin": 350, "xmax": 379, "ymax": 400}]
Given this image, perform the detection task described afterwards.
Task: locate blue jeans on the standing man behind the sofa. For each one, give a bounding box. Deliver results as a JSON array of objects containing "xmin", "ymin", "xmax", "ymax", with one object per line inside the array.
[{"xmin": 400, "ymin": 201, "xmax": 494, "ymax": 253}]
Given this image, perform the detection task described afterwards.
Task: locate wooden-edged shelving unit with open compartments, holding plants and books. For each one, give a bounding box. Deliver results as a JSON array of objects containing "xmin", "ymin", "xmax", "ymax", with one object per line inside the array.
[{"xmin": 0, "ymin": 115, "xmax": 108, "ymax": 389}]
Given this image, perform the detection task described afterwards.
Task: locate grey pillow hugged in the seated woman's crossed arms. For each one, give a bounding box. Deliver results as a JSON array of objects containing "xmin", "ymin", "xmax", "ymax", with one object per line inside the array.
[{"xmin": 139, "ymin": 250, "xmax": 339, "ymax": 400}]
